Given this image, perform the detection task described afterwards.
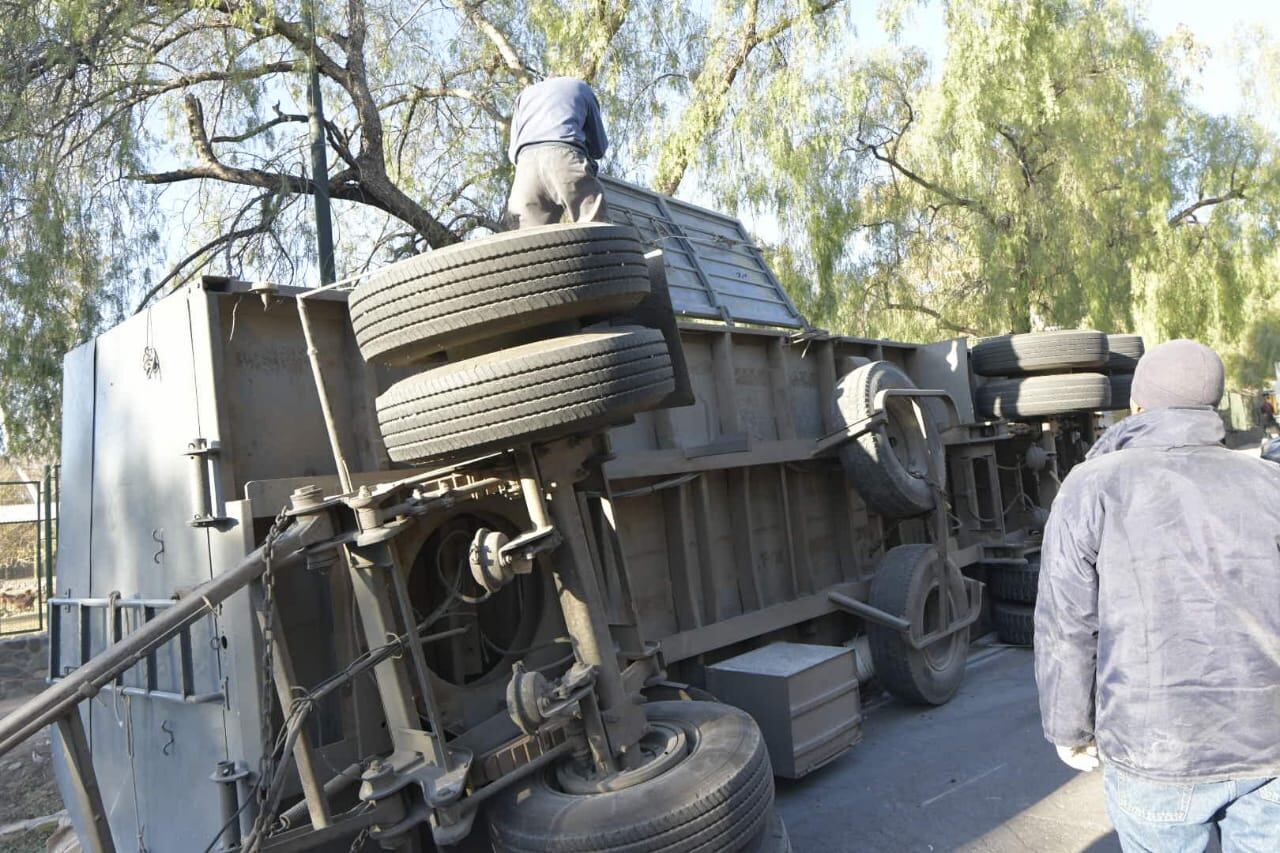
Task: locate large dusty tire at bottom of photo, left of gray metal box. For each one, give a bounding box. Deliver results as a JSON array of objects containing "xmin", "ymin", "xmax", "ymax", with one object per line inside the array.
[{"xmin": 488, "ymin": 702, "xmax": 776, "ymax": 853}]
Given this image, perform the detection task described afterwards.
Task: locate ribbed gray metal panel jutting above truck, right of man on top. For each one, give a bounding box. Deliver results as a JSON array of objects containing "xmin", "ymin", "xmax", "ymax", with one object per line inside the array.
[{"xmin": 602, "ymin": 177, "xmax": 809, "ymax": 329}]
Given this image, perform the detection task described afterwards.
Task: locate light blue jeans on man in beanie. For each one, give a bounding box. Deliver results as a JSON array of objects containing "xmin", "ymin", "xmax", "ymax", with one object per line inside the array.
[{"xmin": 1102, "ymin": 765, "xmax": 1280, "ymax": 853}]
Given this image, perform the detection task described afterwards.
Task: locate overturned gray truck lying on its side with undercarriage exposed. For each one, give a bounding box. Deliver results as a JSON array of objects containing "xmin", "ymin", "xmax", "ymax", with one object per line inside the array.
[{"xmin": 0, "ymin": 175, "xmax": 1121, "ymax": 853}]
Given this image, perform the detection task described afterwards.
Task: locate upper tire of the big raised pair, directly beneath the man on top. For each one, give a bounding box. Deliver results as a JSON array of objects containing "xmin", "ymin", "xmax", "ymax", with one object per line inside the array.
[{"xmin": 348, "ymin": 224, "xmax": 649, "ymax": 364}]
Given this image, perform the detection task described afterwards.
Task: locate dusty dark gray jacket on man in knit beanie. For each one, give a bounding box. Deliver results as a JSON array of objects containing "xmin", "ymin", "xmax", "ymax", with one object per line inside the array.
[{"xmin": 1036, "ymin": 409, "xmax": 1280, "ymax": 781}]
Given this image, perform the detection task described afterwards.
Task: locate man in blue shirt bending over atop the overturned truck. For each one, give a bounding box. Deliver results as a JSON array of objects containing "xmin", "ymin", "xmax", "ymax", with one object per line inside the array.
[{"xmin": 507, "ymin": 77, "xmax": 609, "ymax": 228}]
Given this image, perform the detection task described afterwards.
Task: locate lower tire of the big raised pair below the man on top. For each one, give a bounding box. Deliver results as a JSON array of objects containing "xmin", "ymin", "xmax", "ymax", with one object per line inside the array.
[{"xmin": 378, "ymin": 325, "xmax": 676, "ymax": 462}]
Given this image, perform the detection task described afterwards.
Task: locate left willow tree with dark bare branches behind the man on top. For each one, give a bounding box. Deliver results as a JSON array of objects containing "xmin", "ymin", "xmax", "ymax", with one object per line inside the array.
[{"xmin": 0, "ymin": 0, "xmax": 840, "ymax": 451}]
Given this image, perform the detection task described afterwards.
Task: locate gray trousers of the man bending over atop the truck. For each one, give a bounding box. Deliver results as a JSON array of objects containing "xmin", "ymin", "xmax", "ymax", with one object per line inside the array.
[{"xmin": 507, "ymin": 142, "xmax": 604, "ymax": 228}]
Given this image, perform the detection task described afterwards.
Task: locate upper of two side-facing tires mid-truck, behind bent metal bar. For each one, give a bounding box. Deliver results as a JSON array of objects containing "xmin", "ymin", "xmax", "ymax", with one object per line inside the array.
[{"xmin": 835, "ymin": 361, "xmax": 942, "ymax": 519}]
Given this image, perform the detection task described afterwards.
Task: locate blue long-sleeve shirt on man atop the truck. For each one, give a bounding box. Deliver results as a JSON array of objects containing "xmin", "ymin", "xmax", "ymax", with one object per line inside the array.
[{"xmin": 507, "ymin": 77, "xmax": 609, "ymax": 163}]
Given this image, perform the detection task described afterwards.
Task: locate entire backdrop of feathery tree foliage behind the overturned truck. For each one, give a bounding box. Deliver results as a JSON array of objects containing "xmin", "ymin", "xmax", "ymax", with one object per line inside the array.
[{"xmin": 0, "ymin": 0, "xmax": 1280, "ymax": 456}]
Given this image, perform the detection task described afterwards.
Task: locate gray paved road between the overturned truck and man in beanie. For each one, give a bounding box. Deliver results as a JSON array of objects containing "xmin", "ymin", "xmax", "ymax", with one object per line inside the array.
[{"xmin": 778, "ymin": 647, "xmax": 1120, "ymax": 853}]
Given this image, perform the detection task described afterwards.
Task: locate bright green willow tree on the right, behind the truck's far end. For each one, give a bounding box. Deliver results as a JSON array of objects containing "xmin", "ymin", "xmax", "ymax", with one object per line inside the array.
[{"xmin": 737, "ymin": 0, "xmax": 1280, "ymax": 366}]
